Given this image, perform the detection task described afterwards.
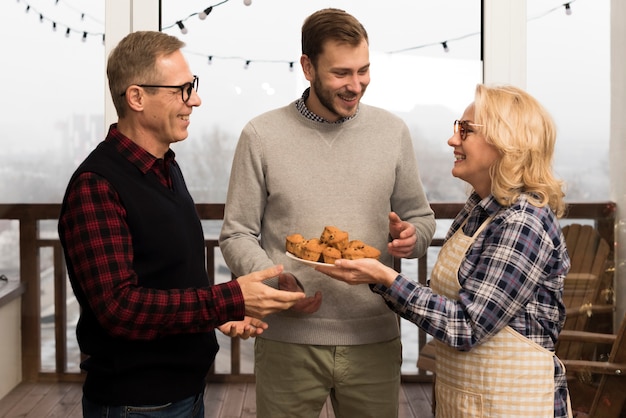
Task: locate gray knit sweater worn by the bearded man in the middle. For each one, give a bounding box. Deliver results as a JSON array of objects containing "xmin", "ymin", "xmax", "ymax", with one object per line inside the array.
[{"xmin": 220, "ymin": 103, "xmax": 435, "ymax": 345}]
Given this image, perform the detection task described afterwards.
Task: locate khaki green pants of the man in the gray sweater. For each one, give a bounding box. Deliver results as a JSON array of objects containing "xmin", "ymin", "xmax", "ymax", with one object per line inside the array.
[{"xmin": 255, "ymin": 337, "xmax": 402, "ymax": 418}]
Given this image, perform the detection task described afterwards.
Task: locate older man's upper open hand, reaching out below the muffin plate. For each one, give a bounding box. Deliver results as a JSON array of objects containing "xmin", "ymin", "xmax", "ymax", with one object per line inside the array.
[{"xmin": 237, "ymin": 265, "xmax": 306, "ymax": 319}]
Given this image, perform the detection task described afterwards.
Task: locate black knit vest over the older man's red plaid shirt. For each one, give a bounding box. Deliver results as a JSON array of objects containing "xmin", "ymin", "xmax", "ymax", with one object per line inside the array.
[{"xmin": 61, "ymin": 142, "xmax": 218, "ymax": 405}]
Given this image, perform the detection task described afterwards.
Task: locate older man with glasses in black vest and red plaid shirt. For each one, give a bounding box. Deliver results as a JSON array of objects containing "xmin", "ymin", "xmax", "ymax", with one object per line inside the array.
[{"xmin": 59, "ymin": 31, "xmax": 305, "ymax": 418}]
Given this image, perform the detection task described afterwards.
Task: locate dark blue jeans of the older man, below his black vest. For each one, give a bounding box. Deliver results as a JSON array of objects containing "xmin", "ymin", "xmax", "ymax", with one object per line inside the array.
[{"xmin": 83, "ymin": 393, "xmax": 204, "ymax": 418}]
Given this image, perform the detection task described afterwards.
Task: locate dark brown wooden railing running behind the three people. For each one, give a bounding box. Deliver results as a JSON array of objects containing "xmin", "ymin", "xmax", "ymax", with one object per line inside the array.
[{"xmin": 0, "ymin": 202, "xmax": 615, "ymax": 382}]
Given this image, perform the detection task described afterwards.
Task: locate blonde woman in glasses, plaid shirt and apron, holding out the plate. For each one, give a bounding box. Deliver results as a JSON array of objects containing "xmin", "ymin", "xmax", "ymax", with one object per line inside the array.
[{"xmin": 318, "ymin": 85, "xmax": 571, "ymax": 418}]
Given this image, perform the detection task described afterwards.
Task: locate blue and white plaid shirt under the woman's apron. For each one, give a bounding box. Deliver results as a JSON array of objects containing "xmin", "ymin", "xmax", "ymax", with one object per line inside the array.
[{"xmin": 372, "ymin": 193, "xmax": 570, "ymax": 417}]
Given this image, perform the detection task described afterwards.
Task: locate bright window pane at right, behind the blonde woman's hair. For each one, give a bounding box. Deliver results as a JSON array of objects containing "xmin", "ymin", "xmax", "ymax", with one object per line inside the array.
[{"xmin": 527, "ymin": 0, "xmax": 611, "ymax": 202}]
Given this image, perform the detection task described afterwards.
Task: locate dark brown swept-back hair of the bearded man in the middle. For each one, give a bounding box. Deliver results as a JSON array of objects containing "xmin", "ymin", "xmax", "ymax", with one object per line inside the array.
[{"xmin": 302, "ymin": 8, "xmax": 369, "ymax": 65}]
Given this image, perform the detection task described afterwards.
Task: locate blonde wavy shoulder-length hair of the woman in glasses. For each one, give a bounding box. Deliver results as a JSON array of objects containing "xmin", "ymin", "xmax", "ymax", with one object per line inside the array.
[{"xmin": 474, "ymin": 84, "xmax": 566, "ymax": 217}]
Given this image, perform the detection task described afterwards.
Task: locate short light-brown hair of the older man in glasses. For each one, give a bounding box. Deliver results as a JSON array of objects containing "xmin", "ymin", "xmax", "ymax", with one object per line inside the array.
[{"xmin": 107, "ymin": 31, "xmax": 185, "ymax": 118}]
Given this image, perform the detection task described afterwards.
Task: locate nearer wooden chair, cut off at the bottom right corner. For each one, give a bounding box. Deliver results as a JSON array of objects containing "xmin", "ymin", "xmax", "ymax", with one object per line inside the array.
[{"xmin": 559, "ymin": 316, "xmax": 626, "ymax": 418}]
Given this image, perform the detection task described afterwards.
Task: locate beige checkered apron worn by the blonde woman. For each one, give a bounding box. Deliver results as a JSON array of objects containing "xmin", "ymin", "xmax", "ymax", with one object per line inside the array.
[{"xmin": 430, "ymin": 218, "xmax": 554, "ymax": 418}]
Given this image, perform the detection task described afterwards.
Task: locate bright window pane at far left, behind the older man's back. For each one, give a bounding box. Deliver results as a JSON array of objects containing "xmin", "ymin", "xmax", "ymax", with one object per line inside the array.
[{"xmin": 0, "ymin": 0, "xmax": 106, "ymax": 203}]
